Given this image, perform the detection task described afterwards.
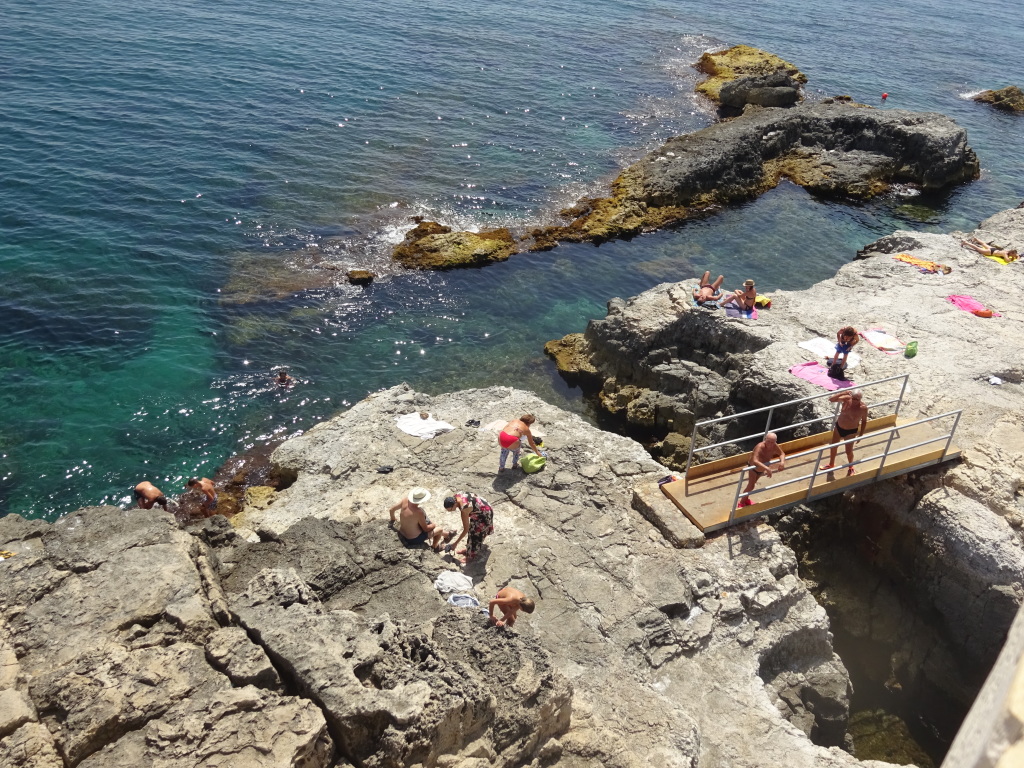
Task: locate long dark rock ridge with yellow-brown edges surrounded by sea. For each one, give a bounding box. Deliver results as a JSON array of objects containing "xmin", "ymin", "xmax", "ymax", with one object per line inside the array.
[{"xmin": 395, "ymin": 100, "xmax": 979, "ymax": 268}]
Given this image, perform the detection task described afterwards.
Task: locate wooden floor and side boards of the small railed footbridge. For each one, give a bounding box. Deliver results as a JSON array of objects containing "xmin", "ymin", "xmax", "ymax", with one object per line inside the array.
[{"xmin": 662, "ymin": 416, "xmax": 961, "ymax": 532}]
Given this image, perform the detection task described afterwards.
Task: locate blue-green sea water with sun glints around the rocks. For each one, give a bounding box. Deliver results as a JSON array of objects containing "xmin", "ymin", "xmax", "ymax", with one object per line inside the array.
[{"xmin": 0, "ymin": 0, "xmax": 1024, "ymax": 519}]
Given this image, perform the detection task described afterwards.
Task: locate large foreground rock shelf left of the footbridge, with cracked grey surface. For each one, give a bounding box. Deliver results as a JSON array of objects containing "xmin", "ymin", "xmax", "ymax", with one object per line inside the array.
[{"xmin": 0, "ymin": 387, "xmax": 897, "ymax": 768}]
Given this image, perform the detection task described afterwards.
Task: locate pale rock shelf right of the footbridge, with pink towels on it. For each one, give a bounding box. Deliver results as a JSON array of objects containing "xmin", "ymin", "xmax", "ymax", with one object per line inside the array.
[{"xmin": 559, "ymin": 209, "xmax": 1024, "ymax": 720}]
